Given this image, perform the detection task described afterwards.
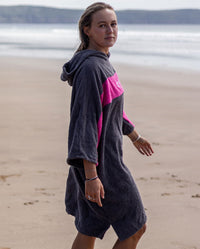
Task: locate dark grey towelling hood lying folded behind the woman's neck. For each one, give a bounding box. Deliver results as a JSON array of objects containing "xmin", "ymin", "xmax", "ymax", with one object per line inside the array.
[{"xmin": 60, "ymin": 50, "xmax": 110, "ymax": 86}]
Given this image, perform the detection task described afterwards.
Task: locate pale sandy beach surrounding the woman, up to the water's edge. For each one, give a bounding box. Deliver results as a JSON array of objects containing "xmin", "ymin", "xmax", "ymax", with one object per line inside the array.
[{"xmin": 0, "ymin": 57, "xmax": 200, "ymax": 249}]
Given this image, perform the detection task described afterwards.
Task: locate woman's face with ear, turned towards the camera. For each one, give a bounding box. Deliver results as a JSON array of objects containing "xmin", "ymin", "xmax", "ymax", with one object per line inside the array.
[{"xmin": 84, "ymin": 9, "xmax": 118, "ymax": 54}]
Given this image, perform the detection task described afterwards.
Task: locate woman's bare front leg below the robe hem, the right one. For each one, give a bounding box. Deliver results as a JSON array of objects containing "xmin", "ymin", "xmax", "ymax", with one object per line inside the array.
[{"xmin": 113, "ymin": 225, "xmax": 146, "ymax": 249}]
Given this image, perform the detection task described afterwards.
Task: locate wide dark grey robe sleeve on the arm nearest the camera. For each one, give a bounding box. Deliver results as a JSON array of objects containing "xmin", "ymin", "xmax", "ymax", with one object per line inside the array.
[{"xmin": 67, "ymin": 66, "xmax": 102, "ymax": 168}]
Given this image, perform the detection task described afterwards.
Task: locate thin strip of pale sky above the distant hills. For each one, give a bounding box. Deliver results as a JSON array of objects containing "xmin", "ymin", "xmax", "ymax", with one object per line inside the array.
[{"xmin": 0, "ymin": 0, "xmax": 200, "ymax": 10}]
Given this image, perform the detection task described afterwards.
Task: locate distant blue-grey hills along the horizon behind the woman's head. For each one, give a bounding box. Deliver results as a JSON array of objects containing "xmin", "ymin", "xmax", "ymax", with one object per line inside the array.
[{"xmin": 0, "ymin": 6, "xmax": 200, "ymax": 24}]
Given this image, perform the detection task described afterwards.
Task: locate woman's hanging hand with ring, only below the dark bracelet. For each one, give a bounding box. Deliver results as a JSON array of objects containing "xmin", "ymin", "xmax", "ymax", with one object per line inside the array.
[{"xmin": 85, "ymin": 178, "xmax": 104, "ymax": 207}]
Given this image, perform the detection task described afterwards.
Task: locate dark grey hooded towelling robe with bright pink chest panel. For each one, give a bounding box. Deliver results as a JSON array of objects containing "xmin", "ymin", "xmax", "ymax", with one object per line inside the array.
[{"xmin": 61, "ymin": 50, "xmax": 146, "ymax": 240}]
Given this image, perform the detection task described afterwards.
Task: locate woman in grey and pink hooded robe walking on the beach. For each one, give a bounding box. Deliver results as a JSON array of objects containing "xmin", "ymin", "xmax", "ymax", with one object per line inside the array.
[{"xmin": 61, "ymin": 3, "xmax": 153, "ymax": 249}]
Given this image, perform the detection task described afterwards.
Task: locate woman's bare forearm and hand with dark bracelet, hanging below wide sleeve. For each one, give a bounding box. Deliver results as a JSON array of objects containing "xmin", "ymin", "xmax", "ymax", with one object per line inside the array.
[{"xmin": 83, "ymin": 160, "xmax": 105, "ymax": 207}]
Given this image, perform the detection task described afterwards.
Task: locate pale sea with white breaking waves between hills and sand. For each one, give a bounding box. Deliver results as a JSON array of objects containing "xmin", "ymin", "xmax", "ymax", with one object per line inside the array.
[{"xmin": 0, "ymin": 24, "xmax": 200, "ymax": 72}]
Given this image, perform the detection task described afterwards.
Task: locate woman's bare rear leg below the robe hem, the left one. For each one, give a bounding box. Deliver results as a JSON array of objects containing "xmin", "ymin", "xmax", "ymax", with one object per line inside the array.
[{"xmin": 72, "ymin": 232, "xmax": 96, "ymax": 249}]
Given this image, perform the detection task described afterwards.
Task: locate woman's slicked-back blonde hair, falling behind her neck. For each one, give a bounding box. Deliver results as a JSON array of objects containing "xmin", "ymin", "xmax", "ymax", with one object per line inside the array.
[{"xmin": 76, "ymin": 2, "xmax": 114, "ymax": 52}]
